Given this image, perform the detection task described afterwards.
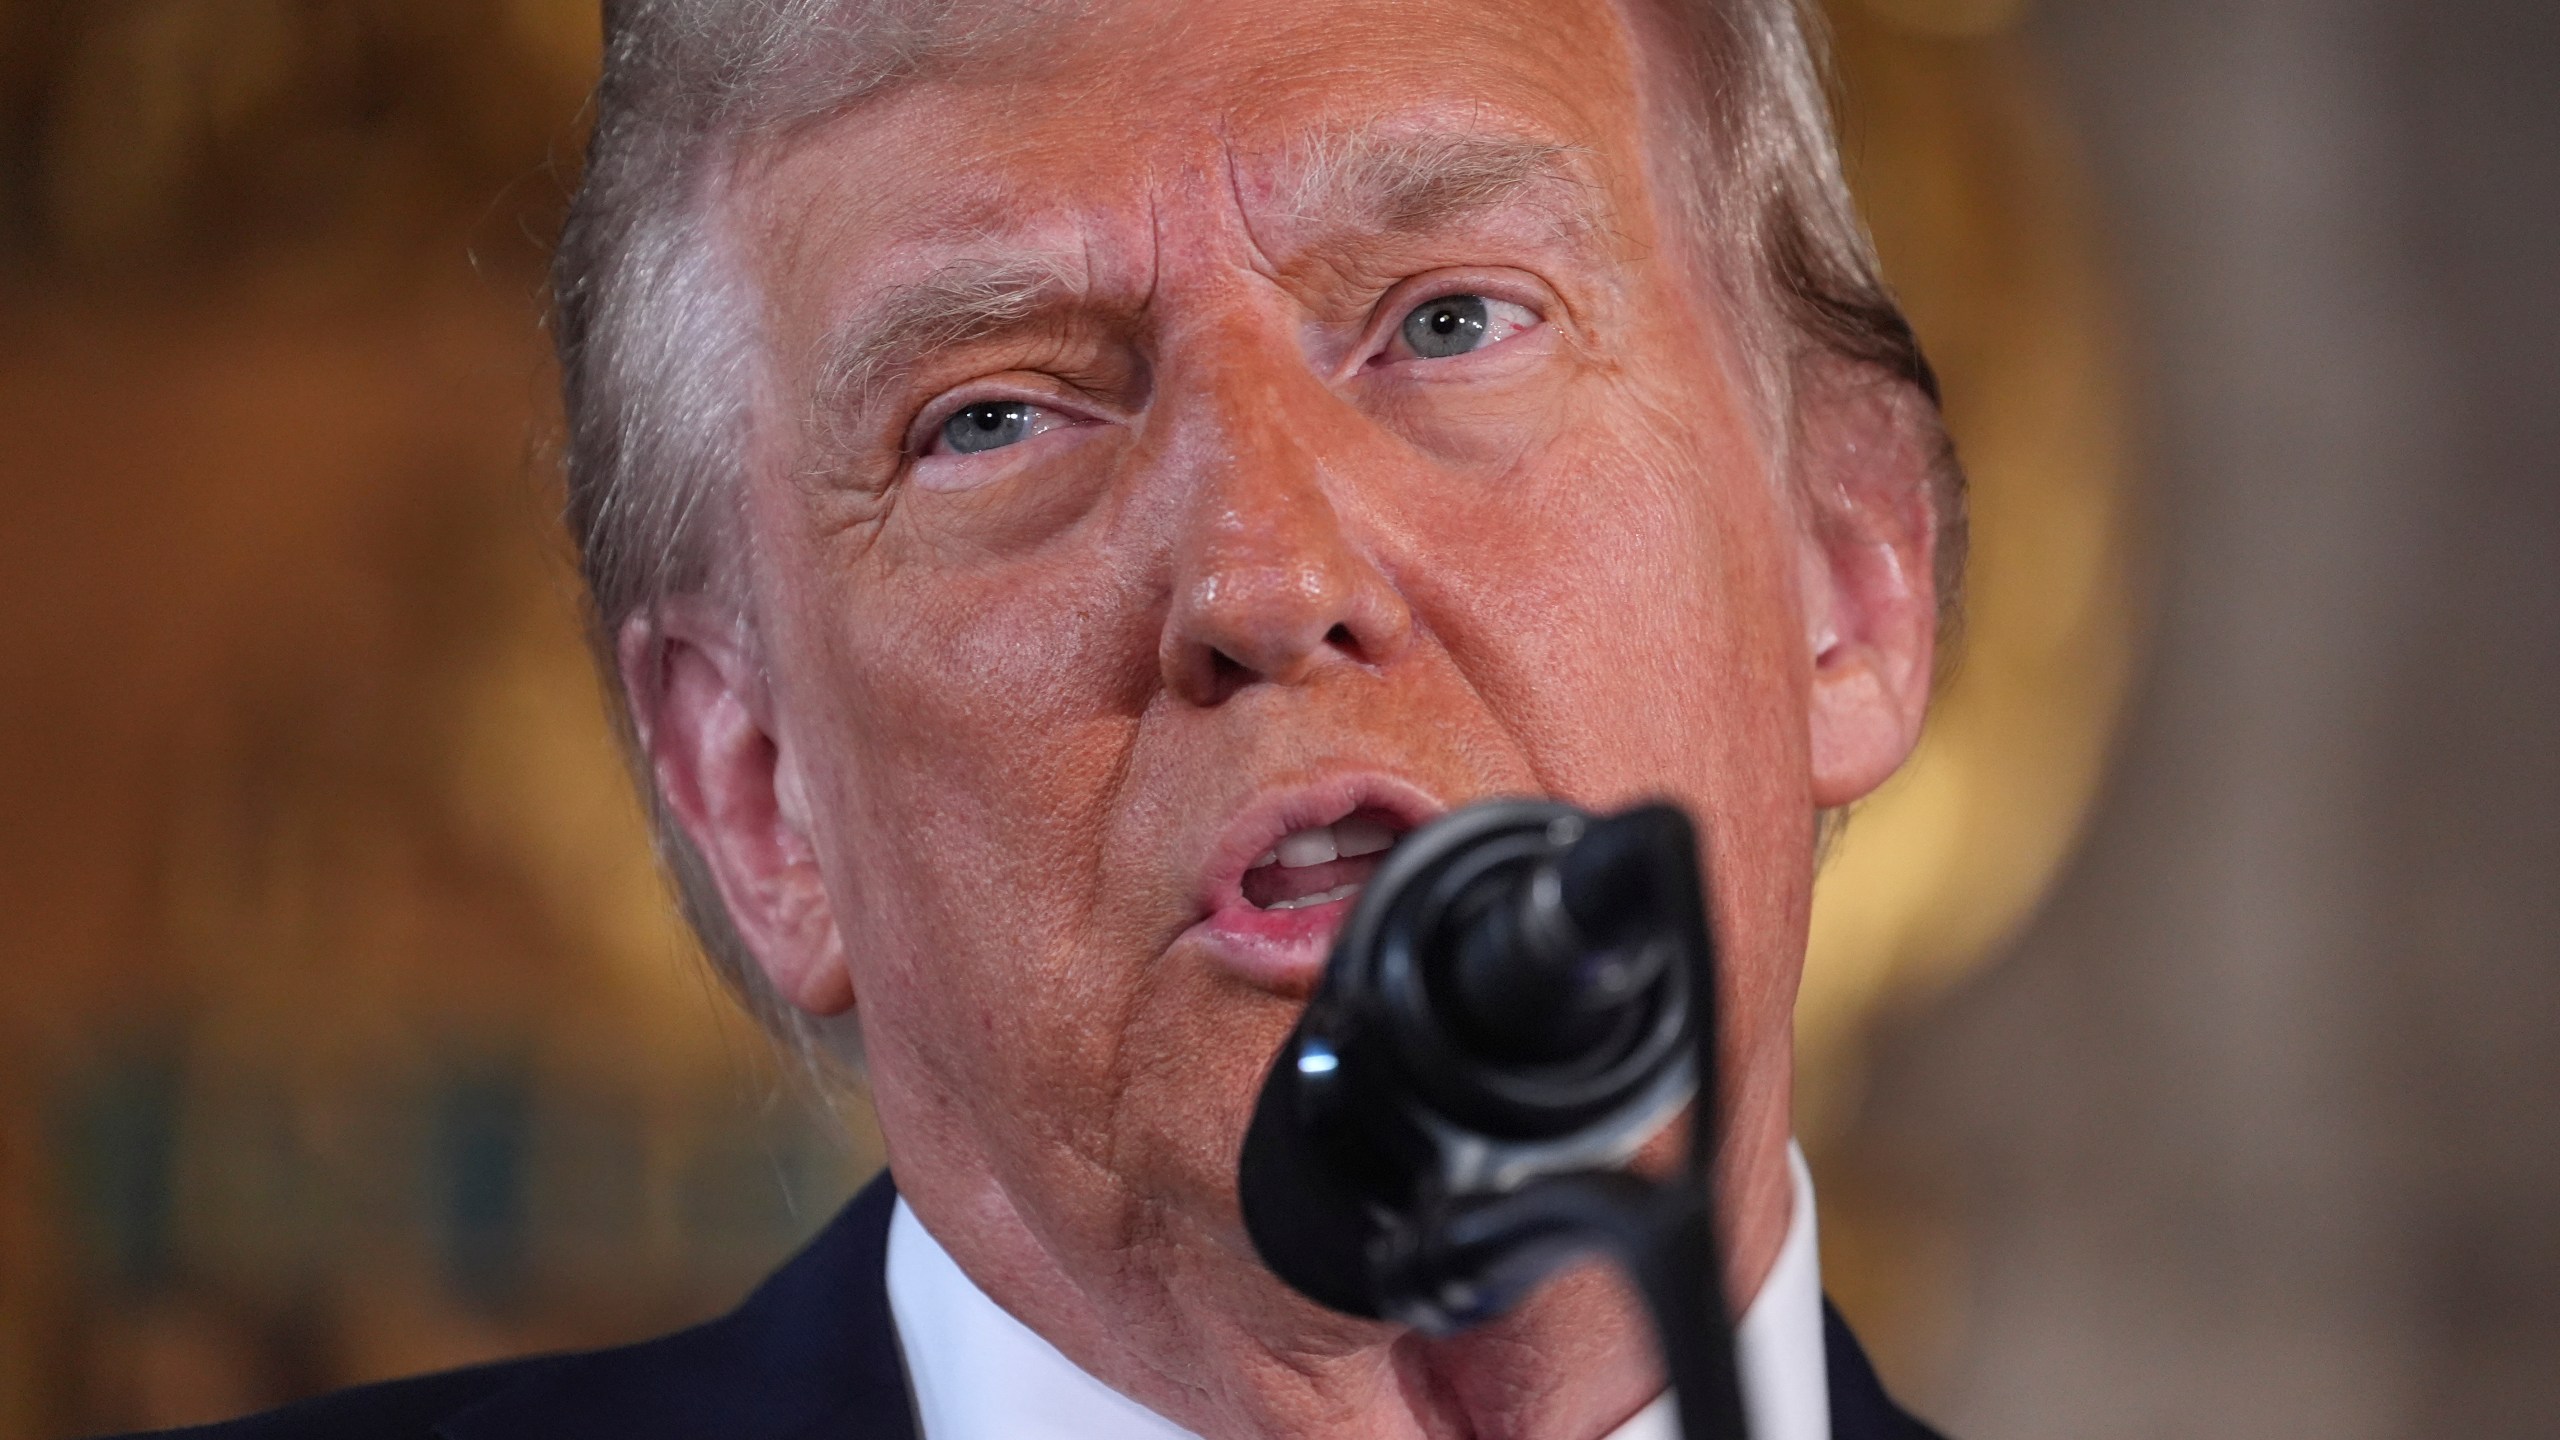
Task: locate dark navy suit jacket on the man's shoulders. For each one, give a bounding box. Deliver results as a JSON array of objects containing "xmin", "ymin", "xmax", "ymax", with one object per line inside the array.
[{"xmin": 124, "ymin": 1176, "xmax": 1935, "ymax": 1440}]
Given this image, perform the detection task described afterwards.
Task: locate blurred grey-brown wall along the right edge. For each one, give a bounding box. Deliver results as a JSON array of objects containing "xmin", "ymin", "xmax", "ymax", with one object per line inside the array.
[{"xmin": 1843, "ymin": 0, "xmax": 2560, "ymax": 1440}]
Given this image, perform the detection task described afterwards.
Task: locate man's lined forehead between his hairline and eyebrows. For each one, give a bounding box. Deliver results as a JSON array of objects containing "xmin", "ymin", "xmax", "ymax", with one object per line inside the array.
[{"xmin": 748, "ymin": 0, "xmax": 1641, "ymax": 279}]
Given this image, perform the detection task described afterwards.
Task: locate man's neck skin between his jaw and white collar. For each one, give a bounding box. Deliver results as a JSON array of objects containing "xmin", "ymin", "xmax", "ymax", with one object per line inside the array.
[{"xmin": 909, "ymin": 1097, "xmax": 1792, "ymax": 1440}]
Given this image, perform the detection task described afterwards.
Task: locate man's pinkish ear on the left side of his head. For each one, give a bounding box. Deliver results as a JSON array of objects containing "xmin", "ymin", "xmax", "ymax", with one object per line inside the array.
[{"xmin": 614, "ymin": 597, "xmax": 852, "ymax": 1015}]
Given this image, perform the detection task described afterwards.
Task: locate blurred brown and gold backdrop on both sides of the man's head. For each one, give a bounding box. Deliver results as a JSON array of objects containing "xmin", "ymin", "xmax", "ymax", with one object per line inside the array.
[{"xmin": 0, "ymin": 0, "xmax": 2138, "ymax": 1437}]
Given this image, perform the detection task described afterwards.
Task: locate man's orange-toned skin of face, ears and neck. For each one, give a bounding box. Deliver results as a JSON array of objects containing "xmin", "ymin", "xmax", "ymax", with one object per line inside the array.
[{"xmin": 622, "ymin": 0, "xmax": 1935, "ymax": 1440}]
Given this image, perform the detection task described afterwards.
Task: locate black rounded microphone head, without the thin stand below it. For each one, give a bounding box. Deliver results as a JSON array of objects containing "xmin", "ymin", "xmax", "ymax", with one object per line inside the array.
[{"xmin": 1236, "ymin": 802, "xmax": 1713, "ymax": 1322}]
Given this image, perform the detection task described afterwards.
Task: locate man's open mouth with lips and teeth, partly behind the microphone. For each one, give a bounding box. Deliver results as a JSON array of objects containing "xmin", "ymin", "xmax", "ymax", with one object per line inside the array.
[{"xmin": 1190, "ymin": 776, "xmax": 1444, "ymax": 999}]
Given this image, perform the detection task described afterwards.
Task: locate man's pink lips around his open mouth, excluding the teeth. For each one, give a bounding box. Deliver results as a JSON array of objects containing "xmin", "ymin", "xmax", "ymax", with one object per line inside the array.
[{"xmin": 1178, "ymin": 771, "xmax": 1449, "ymax": 999}]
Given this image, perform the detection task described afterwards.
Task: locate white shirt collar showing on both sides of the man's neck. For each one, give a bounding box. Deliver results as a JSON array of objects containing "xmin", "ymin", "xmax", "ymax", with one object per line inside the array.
[{"xmin": 888, "ymin": 1145, "xmax": 1830, "ymax": 1440}]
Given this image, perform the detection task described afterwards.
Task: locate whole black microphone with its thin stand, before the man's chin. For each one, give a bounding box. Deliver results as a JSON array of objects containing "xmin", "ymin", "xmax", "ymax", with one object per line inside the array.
[{"xmin": 1236, "ymin": 799, "xmax": 1743, "ymax": 1440}]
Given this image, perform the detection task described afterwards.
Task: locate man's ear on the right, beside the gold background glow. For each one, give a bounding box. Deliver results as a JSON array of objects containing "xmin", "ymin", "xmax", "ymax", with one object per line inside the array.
[{"xmin": 1797, "ymin": 372, "xmax": 1943, "ymax": 810}]
